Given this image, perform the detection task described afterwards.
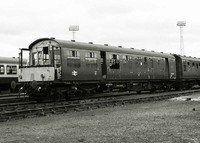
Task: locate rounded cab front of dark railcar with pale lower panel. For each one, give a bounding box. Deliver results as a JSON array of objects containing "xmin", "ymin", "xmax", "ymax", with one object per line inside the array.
[{"xmin": 18, "ymin": 38, "xmax": 61, "ymax": 100}]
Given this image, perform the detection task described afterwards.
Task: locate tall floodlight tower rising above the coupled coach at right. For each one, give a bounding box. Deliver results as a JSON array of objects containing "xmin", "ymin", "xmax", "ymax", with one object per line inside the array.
[{"xmin": 177, "ymin": 21, "xmax": 186, "ymax": 56}]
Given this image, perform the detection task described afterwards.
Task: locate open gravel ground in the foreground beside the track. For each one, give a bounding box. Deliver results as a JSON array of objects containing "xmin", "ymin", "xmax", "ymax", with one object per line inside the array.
[{"xmin": 0, "ymin": 93, "xmax": 200, "ymax": 143}]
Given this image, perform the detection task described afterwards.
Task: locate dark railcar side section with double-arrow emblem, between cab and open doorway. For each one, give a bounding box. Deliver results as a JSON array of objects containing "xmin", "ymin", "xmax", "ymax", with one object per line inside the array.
[{"xmin": 61, "ymin": 48, "xmax": 102, "ymax": 82}]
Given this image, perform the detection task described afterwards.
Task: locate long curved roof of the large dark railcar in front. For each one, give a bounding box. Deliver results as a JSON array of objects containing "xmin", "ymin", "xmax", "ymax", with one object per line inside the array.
[{"xmin": 29, "ymin": 38, "xmax": 175, "ymax": 58}]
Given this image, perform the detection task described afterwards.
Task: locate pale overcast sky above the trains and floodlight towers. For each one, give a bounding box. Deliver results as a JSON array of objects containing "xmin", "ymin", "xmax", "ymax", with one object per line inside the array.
[{"xmin": 0, "ymin": 0, "xmax": 200, "ymax": 58}]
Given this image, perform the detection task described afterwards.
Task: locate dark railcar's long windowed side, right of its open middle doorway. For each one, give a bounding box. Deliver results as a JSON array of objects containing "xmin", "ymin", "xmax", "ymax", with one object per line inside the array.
[{"xmin": 107, "ymin": 52, "xmax": 176, "ymax": 80}]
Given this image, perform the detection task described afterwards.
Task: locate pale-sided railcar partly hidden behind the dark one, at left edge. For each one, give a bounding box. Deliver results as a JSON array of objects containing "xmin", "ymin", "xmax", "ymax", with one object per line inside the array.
[{"xmin": 0, "ymin": 57, "xmax": 22, "ymax": 91}]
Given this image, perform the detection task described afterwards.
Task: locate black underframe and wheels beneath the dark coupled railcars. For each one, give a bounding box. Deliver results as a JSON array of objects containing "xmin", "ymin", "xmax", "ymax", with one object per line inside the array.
[{"xmin": 20, "ymin": 80, "xmax": 197, "ymax": 101}]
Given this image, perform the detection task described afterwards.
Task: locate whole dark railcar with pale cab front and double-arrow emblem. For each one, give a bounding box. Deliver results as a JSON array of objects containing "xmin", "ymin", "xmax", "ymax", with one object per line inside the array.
[{"xmin": 18, "ymin": 38, "xmax": 180, "ymax": 100}]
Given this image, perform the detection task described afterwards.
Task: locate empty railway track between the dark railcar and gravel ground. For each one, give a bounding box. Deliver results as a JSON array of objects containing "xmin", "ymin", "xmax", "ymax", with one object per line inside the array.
[{"xmin": 0, "ymin": 89, "xmax": 200, "ymax": 122}]
